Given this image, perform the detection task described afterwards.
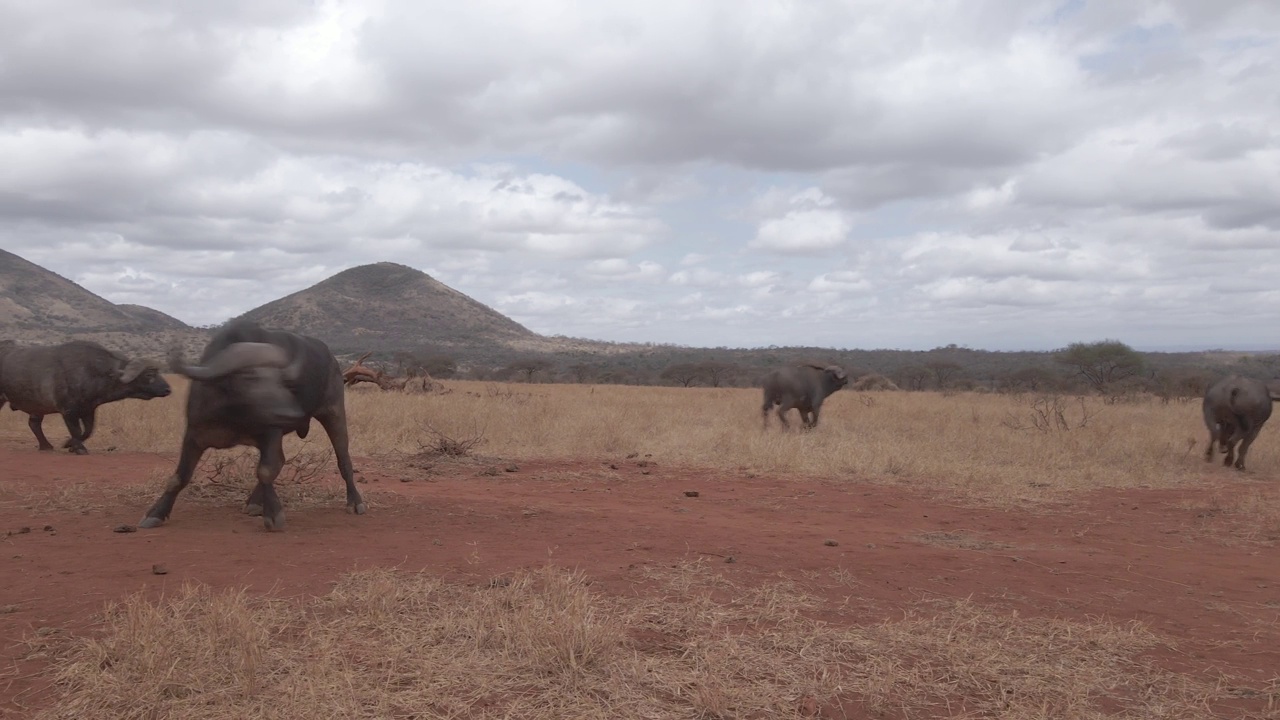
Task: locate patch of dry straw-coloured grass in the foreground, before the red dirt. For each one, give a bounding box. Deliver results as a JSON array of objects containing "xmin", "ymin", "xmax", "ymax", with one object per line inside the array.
[{"xmin": 38, "ymin": 564, "xmax": 1275, "ymax": 720}]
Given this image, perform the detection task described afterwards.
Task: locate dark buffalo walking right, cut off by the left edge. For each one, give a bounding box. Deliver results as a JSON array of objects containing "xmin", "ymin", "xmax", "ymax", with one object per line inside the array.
[{"xmin": 0, "ymin": 340, "xmax": 170, "ymax": 455}]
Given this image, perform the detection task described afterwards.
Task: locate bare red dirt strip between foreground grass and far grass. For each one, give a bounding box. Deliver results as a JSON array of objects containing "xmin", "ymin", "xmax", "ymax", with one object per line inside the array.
[{"xmin": 0, "ymin": 438, "xmax": 1280, "ymax": 717}]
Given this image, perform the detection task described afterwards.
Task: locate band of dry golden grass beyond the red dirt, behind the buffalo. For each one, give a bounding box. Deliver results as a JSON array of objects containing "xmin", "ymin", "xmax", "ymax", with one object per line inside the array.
[{"xmin": 0, "ymin": 379, "xmax": 1259, "ymax": 502}]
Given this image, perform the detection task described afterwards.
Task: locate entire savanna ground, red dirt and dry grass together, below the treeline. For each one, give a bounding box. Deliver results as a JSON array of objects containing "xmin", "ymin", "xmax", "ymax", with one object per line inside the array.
[{"xmin": 0, "ymin": 378, "xmax": 1280, "ymax": 720}]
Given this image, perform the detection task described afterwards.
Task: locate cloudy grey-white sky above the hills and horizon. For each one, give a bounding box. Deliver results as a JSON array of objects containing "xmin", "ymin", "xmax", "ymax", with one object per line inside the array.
[{"xmin": 0, "ymin": 0, "xmax": 1280, "ymax": 350}]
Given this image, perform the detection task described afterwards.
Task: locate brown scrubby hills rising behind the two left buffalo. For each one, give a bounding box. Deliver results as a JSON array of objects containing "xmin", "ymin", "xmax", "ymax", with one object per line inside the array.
[{"xmin": 0, "ymin": 250, "xmax": 625, "ymax": 359}]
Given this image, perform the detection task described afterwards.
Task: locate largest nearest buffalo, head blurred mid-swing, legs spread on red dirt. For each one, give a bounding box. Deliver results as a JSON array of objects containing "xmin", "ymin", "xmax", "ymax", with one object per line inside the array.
[{"xmin": 138, "ymin": 320, "xmax": 366, "ymax": 530}]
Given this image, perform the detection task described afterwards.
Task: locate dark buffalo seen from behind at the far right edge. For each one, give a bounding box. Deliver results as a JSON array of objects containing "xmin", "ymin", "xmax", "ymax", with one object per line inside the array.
[{"xmin": 1201, "ymin": 375, "xmax": 1280, "ymax": 470}]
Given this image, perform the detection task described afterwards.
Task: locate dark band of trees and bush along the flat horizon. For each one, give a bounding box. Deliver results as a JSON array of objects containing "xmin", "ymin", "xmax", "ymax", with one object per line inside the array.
[{"xmin": 345, "ymin": 340, "xmax": 1280, "ymax": 400}]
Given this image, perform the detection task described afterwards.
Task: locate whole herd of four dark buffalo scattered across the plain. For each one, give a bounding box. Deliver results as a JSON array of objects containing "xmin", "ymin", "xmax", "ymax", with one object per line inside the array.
[{"xmin": 0, "ymin": 320, "xmax": 1280, "ymax": 530}]
